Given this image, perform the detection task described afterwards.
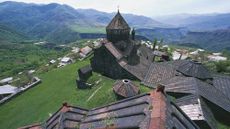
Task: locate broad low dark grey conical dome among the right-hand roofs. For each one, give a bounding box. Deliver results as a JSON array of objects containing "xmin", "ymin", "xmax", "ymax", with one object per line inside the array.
[{"xmin": 177, "ymin": 61, "xmax": 212, "ymax": 79}]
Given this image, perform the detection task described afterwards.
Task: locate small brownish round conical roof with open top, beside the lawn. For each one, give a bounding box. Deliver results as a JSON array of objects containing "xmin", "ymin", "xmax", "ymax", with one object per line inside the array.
[{"xmin": 113, "ymin": 79, "xmax": 139, "ymax": 98}]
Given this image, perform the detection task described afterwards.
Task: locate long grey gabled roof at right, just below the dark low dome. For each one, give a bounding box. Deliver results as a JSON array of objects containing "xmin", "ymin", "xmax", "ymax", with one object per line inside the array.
[{"xmin": 160, "ymin": 76, "xmax": 230, "ymax": 112}]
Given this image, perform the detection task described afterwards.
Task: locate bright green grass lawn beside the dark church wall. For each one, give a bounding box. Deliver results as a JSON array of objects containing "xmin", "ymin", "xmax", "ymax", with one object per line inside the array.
[{"xmin": 0, "ymin": 59, "xmax": 149, "ymax": 129}]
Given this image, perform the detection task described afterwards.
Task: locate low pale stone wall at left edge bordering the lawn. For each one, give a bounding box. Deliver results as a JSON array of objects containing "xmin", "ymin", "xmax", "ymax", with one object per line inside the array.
[{"xmin": 0, "ymin": 77, "xmax": 41, "ymax": 105}]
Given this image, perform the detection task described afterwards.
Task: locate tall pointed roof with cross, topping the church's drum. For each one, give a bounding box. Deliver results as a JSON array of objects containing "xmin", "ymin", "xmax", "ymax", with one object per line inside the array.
[{"xmin": 106, "ymin": 10, "xmax": 130, "ymax": 29}]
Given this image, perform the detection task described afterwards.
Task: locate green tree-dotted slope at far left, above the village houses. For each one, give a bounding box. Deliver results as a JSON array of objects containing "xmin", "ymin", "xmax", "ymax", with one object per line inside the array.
[{"xmin": 0, "ymin": 42, "xmax": 68, "ymax": 79}]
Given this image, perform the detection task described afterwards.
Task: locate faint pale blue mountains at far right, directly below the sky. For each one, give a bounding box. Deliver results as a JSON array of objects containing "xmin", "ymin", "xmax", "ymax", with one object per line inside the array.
[{"xmin": 158, "ymin": 13, "xmax": 230, "ymax": 31}]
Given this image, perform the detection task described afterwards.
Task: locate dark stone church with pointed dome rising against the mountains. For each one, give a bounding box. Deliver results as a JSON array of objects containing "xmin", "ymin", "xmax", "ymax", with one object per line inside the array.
[{"xmin": 91, "ymin": 10, "xmax": 153, "ymax": 80}]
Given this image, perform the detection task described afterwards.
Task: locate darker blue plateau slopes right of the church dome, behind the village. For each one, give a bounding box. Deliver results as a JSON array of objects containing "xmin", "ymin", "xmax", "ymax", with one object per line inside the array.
[{"xmin": 136, "ymin": 28, "xmax": 230, "ymax": 51}]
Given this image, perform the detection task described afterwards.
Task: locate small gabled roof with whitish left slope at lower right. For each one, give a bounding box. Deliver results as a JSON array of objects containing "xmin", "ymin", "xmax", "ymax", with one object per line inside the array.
[{"xmin": 175, "ymin": 95, "xmax": 217, "ymax": 129}]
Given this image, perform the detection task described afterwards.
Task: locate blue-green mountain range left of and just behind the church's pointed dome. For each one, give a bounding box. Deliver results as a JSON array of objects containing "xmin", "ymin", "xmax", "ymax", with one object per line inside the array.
[{"xmin": 0, "ymin": 2, "xmax": 166, "ymax": 43}]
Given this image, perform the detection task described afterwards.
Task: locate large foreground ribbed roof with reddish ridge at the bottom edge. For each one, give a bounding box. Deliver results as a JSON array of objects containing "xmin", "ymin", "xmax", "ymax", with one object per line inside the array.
[{"xmin": 19, "ymin": 89, "xmax": 199, "ymax": 129}]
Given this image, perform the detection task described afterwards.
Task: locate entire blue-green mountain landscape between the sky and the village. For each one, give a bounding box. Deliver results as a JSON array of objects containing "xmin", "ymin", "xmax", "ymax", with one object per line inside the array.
[{"xmin": 0, "ymin": 2, "xmax": 230, "ymax": 51}]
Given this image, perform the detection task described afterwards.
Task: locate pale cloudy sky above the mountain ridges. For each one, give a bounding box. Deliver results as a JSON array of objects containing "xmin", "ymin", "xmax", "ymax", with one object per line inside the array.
[{"xmin": 0, "ymin": 0, "xmax": 230, "ymax": 17}]
